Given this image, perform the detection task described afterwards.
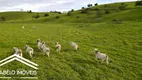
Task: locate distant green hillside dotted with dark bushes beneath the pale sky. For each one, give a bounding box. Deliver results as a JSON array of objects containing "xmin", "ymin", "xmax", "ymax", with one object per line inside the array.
[{"xmin": 0, "ymin": 2, "xmax": 142, "ymax": 23}]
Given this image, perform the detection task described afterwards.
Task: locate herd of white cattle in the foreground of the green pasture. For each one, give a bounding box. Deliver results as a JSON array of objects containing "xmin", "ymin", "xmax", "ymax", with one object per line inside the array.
[{"xmin": 13, "ymin": 39, "xmax": 108, "ymax": 64}]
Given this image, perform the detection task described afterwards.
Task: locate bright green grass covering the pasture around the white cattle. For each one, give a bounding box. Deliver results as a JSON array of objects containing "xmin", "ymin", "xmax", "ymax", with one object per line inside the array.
[{"xmin": 0, "ymin": 3, "xmax": 142, "ymax": 80}]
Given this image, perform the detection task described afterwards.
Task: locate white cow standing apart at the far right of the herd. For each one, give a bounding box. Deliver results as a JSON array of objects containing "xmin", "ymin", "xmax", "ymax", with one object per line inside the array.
[{"xmin": 94, "ymin": 49, "xmax": 108, "ymax": 65}]
